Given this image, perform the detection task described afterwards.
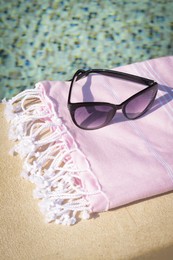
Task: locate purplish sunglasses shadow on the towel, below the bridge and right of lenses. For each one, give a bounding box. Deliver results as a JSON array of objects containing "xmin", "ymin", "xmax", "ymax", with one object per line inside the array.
[{"xmin": 109, "ymin": 85, "xmax": 173, "ymax": 125}]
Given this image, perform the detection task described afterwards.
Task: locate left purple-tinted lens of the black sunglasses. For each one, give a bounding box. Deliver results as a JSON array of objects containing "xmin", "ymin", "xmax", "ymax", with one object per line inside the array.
[{"xmin": 74, "ymin": 105, "xmax": 115, "ymax": 130}]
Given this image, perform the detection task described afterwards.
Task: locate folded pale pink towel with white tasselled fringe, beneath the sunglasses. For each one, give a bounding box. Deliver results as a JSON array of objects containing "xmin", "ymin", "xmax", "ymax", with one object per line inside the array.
[{"xmin": 5, "ymin": 56, "xmax": 173, "ymax": 225}]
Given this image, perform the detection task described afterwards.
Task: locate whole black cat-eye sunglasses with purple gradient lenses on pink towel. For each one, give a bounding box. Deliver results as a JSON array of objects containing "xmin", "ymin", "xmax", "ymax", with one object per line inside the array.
[{"xmin": 68, "ymin": 69, "xmax": 158, "ymax": 130}]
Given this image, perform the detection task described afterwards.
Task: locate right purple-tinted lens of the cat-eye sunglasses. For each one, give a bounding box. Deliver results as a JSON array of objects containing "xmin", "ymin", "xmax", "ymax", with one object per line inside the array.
[{"xmin": 124, "ymin": 85, "xmax": 157, "ymax": 119}]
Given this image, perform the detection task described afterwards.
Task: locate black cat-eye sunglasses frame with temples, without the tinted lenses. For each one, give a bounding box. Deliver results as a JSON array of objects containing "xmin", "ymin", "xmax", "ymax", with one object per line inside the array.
[{"xmin": 67, "ymin": 69, "xmax": 158, "ymax": 130}]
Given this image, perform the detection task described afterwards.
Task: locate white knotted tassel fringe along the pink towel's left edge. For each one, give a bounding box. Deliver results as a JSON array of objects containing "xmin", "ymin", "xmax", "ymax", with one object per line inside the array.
[{"xmin": 4, "ymin": 88, "xmax": 99, "ymax": 225}]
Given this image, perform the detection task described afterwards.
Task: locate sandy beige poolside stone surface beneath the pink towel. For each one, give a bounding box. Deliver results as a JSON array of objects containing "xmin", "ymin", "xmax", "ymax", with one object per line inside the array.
[{"xmin": 0, "ymin": 104, "xmax": 173, "ymax": 260}]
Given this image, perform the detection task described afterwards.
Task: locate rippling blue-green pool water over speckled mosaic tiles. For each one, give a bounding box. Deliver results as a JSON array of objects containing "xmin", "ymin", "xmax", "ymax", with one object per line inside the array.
[{"xmin": 0, "ymin": 0, "xmax": 173, "ymax": 99}]
